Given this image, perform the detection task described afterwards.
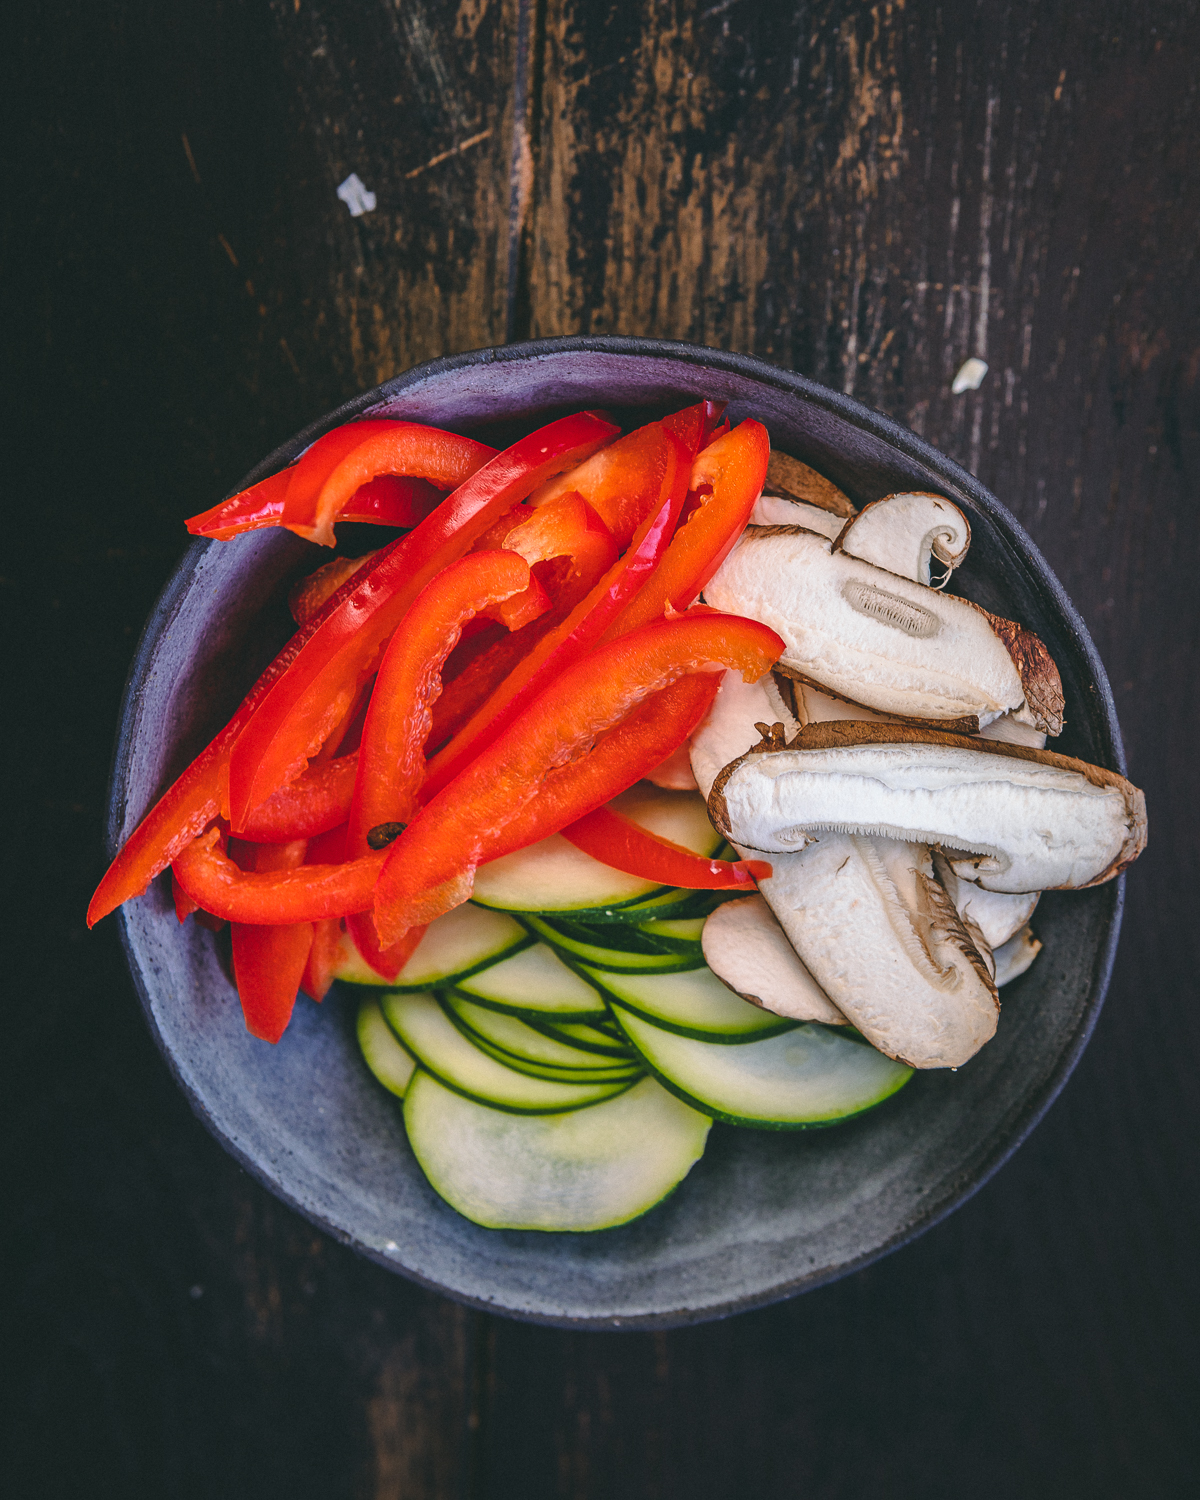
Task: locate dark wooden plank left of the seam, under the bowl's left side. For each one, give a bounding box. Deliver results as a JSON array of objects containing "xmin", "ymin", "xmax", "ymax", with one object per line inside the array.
[{"xmin": 0, "ymin": 0, "xmax": 516, "ymax": 1497}]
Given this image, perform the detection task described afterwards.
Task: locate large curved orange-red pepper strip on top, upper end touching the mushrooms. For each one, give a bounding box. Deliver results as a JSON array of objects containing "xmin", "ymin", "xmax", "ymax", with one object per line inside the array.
[{"xmin": 375, "ymin": 614, "xmax": 783, "ymax": 944}]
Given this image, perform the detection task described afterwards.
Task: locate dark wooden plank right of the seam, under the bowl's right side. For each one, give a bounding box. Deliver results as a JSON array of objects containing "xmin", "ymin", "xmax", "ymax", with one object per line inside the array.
[{"xmin": 477, "ymin": 3, "xmax": 1200, "ymax": 1500}]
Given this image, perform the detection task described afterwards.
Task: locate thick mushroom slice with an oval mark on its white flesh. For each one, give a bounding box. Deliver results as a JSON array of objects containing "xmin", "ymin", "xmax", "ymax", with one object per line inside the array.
[{"xmin": 704, "ymin": 527, "xmax": 1062, "ymax": 734}]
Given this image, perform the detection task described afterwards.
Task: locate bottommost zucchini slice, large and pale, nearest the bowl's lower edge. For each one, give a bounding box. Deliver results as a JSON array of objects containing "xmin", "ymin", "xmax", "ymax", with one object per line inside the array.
[{"xmin": 404, "ymin": 1073, "xmax": 710, "ymax": 1230}]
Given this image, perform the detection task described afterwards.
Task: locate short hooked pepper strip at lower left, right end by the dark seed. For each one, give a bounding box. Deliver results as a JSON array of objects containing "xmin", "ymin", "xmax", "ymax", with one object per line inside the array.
[{"xmin": 171, "ymin": 828, "xmax": 387, "ymax": 927}]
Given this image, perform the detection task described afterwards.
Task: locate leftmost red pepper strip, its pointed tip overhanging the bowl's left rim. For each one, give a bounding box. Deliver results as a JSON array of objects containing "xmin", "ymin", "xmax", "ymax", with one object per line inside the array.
[{"xmin": 87, "ymin": 552, "xmax": 387, "ymax": 927}]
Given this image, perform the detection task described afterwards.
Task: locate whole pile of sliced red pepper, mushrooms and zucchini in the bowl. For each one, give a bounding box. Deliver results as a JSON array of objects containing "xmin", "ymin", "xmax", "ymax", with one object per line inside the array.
[{"xmin": 89, "ymin": 381, "xmax": 1146, "ymax": 1230}]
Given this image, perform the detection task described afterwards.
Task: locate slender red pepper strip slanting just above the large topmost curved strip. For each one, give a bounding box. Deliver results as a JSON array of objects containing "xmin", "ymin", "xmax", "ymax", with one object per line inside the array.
[{"xmin": 425, "ymin": 407, "xmax": 704, "ymax": 800}]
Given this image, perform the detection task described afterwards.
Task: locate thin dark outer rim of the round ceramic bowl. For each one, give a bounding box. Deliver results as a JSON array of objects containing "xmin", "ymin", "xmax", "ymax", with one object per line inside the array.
[{"xmin": 105, "ymin": 336, "xmax": 1127, "ymax": 1331}]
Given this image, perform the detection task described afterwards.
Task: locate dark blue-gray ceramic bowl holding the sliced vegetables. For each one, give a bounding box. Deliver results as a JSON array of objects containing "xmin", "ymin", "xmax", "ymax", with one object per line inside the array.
[{"xmin": 110, "ymin": 339, "xmax": 1124, "ymax": 1328}]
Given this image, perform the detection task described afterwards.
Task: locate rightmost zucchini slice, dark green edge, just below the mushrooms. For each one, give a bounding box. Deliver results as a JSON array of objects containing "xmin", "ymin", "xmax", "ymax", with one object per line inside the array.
[{"xmin": 614, "ymin": 1005, "xmax": 912, "ymax": 1130}]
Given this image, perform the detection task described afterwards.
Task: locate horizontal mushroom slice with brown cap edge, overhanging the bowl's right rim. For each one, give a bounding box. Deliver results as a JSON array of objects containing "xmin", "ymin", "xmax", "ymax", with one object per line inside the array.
[{"xmin": 708, "ymin": 723, "xmax": 1146, "ymax": 888}]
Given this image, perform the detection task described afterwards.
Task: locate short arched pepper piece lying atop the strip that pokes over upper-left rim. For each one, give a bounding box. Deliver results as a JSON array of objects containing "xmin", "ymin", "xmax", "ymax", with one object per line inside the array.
[{"xmin": 300, "ymin": 422, "xmax": 507, "ymax": 548}]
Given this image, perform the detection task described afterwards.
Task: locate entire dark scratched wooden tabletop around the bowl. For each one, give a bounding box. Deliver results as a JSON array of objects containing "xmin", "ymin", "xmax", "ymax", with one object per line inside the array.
[{"xmin": 9, "ymin": 0, "xmax": 1200, "ymax": 1500}]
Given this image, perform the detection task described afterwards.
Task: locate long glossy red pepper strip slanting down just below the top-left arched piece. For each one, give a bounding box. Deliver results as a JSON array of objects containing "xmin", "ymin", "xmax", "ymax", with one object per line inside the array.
[{"xmin": 230, "ymin": 413, "xmax": 617, "ymax": 827}]
